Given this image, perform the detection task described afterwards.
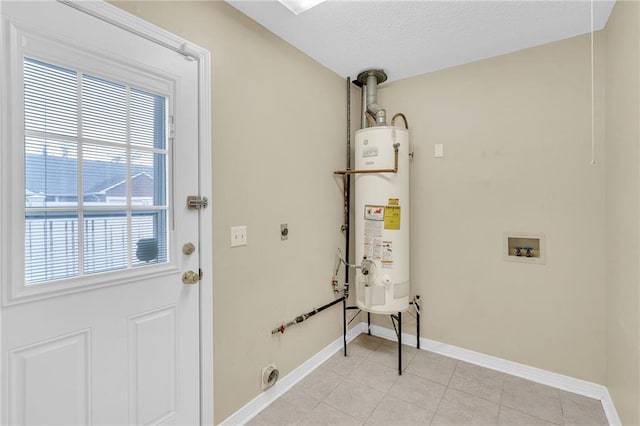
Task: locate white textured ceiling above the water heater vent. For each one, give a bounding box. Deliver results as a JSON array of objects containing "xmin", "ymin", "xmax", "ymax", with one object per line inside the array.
[{"xmin": 227, "ymin": 0, "xmax": 615, "ymax": 81}]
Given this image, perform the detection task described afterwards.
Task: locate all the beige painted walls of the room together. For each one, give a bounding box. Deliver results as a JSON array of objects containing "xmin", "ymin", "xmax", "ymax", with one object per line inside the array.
[{"xmin": 110, "ymin": 2, "xmax": 640, "ymax": 424}]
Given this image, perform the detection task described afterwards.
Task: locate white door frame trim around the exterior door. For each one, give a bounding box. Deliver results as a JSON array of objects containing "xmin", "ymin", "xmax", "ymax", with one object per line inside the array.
[{"xmin": 0, "ymin": 0, "xmax": 214, "ymax": 425}]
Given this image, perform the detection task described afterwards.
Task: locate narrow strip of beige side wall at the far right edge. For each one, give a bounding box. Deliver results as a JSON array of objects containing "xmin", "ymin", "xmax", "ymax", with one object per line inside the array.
[{"xmin": 606, "ymin": 1, "xmax": 640, "ymax": 425}]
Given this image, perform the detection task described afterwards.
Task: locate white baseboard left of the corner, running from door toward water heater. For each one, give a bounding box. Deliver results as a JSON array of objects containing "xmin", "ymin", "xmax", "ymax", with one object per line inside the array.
[{"xmin": 220, "ymin": 323, "xmax": 366, "ymax": 426}]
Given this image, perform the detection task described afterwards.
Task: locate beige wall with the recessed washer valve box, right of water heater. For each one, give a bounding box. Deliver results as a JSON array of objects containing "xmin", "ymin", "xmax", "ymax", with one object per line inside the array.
[{"xmin": 378, "ymin": 33, "xmax": 606, "ymax": 383}]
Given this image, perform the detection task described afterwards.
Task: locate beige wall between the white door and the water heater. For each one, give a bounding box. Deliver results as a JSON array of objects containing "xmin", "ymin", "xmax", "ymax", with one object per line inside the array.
[{"xmin": 115, "ymin": 1, "xmax": 346, "ymax": 423}]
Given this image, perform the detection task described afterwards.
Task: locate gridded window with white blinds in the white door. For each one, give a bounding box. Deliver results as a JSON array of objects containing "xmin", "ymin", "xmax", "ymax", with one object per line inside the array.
[{"xmin": 23, "ymin": 57, "xmax": 169, "ymax": 285}]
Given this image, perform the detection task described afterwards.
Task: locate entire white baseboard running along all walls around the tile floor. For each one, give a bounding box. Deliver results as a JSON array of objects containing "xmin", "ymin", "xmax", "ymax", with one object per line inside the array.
[{"xmin": 221, "ymin": 322, "xmax": 621, "ymax": 426}]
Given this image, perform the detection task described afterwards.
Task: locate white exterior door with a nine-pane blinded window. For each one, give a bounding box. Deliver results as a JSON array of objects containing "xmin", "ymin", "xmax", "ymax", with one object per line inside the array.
[{"xmin": 0, "ymin": 1, "xmax": 200, "ymax": 425}]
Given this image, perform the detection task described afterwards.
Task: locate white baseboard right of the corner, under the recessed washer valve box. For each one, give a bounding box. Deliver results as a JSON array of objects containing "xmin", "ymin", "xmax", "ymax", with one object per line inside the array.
[{"xmin": 359, "ymin": 323, "xmax": 621, "ymax": 426}]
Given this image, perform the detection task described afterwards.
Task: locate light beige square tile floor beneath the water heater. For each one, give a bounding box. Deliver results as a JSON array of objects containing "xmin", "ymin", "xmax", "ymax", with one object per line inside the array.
[{"xmin": 249, "ymin": 334, "xmax": 608, "ymax": 426}]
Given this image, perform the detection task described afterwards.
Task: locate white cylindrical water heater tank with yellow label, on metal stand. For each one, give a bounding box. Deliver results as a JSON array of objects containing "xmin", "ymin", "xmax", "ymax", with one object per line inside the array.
[{"xmin": 354, "ymin": 126, "xmax": 409, "ymax": 314}]
